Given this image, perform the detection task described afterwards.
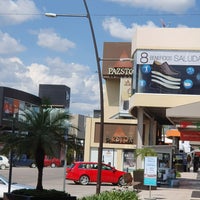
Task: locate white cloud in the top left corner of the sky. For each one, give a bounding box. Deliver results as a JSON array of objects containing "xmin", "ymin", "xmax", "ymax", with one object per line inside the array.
[{"xmin": 0, "ymin": 0, "xmax": 39, "ymax": 24}]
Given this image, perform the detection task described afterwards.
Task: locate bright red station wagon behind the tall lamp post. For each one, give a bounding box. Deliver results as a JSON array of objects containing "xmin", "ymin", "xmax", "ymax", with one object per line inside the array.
[{"xmin": 66, "ymin": 162, "xmax": 126, "ymax": 185}]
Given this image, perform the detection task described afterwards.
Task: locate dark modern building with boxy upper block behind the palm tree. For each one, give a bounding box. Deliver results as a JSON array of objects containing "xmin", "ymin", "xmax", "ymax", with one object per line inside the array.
[{"xmin": 0, "ymin": 84, "xmax": 73, "ymax": 160}]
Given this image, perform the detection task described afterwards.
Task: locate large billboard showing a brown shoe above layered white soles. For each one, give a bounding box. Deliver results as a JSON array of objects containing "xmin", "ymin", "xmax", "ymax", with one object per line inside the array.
[{"xmin": 133, "ymin": 50, "xmax": 200, "ymax": 95}]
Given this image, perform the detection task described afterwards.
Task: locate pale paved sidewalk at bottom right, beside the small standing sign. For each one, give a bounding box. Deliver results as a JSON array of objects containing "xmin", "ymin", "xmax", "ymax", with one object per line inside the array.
[{"xmin": 138, "ymin": 172, "xmax": 200, "ymax": 200}]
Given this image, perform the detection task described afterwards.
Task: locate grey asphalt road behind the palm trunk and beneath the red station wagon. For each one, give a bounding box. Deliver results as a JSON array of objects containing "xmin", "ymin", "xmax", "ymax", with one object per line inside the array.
[{"xmin": 0, "ymin": 167, "xmax": 116, "ymax": 198}]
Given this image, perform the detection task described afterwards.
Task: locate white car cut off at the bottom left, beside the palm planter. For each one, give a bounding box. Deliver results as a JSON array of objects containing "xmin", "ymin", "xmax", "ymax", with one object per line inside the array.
[{"xmin": 0, "ymin": 175, "xmax": 34, "ymax": 199}]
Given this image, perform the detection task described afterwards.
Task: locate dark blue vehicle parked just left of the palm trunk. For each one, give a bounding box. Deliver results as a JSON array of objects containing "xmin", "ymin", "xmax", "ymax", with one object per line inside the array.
[{"xmin": 13, "ymin": 154, "xmax": 36, "ymax": 168}]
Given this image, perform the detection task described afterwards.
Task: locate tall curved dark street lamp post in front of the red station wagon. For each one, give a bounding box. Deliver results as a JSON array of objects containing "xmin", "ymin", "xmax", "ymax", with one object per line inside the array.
[{"xmin": 45, "ymin": 0, "xmax": 104, "ymax": 194}]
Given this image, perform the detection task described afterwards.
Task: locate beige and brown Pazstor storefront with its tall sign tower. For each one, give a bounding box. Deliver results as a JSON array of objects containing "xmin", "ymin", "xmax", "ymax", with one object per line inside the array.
[{"xmin": 84, "ymin": 42, "xmax": 137, "ymax": 171}]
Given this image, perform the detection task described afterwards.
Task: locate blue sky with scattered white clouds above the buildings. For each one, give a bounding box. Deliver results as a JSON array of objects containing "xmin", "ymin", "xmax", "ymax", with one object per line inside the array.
[{"xmin": 0, "ymin": 0, "xmax": 200, "ymax": 115}]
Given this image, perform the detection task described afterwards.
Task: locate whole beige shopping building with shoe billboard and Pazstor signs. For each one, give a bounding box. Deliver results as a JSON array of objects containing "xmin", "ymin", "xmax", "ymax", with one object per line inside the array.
[{"xmin": 84, "ymin": 28, "xmax": 200, "ymax": 171}]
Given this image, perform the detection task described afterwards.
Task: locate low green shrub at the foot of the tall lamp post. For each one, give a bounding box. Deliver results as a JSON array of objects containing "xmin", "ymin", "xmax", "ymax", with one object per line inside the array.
[{"xmin": 79, "ymin": 190, "xmax": 139, "ymax": 200}]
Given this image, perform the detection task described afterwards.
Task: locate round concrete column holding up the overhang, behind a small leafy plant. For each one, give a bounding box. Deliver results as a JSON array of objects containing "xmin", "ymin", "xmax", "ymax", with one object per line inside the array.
[{"xmin": 136, "ymin": 107, "xmax": 144, "ymax": 169}]
